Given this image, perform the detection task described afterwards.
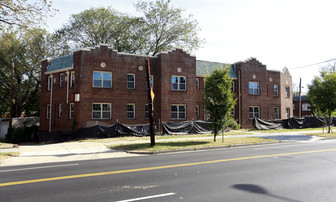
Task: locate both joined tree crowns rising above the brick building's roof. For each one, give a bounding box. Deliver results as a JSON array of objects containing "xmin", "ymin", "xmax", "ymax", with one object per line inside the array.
[{"xmin": 53, "ymin": 0, "xmax": 203, "ymax": 55}]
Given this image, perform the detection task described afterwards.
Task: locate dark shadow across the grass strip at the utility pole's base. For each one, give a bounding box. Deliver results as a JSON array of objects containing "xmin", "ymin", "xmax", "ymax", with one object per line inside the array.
[{"xmin": 110, "ymin": 141, "xmax": 209, "ymax": 151}]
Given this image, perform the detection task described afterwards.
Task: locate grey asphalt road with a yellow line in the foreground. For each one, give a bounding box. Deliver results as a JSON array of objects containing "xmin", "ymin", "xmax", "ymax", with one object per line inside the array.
[{"xmin": 0, "ymin": 140, "xmax": 336, "ymax": 201}]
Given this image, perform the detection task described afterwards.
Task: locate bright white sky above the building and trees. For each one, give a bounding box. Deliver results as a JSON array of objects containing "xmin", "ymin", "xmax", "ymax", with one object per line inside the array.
[{"xmin": 47, "ymin": 0, "xmax": 336, "ymax": 92}]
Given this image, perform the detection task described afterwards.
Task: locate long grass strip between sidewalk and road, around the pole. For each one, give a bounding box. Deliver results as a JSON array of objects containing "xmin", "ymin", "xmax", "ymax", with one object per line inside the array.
[{"xmin": 109, "ymin": 137, "xmax": 278, "ymax": 152}]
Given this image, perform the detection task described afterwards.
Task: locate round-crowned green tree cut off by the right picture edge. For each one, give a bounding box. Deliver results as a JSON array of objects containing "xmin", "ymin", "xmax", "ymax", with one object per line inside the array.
[{"xmin": 307, "ymin": 71, "xmax": 336, "ymax": 133}]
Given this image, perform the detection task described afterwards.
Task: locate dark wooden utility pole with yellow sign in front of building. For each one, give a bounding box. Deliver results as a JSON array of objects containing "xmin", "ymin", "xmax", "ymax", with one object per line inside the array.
[{"xmin": 146, "ymin": 57, "xmax": 155, "ymax": 147}]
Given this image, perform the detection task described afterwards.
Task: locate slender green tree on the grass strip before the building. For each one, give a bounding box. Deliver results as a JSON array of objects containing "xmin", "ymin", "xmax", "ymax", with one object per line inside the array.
[{"xmin": 203, "ymin": 67, "xmax": 236, "ymax": 142}]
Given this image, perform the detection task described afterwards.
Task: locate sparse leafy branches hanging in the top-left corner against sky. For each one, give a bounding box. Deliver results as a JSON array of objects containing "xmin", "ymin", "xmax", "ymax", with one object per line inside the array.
[{"xmin": 0, "ymin": 0, "xmax": 56, "ymax": 29}]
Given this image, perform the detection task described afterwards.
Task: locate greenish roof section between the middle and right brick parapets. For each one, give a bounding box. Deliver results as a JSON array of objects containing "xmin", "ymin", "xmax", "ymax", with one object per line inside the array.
[{"xmin": 196, "ymin": 60, "xmax": 238, "ymax": 79}]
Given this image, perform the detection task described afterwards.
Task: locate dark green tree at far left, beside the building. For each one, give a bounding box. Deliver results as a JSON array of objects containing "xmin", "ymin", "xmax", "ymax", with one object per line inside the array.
[{"xmin": 0, "ymin": 29, "xmax": 49, "ymax": 117}]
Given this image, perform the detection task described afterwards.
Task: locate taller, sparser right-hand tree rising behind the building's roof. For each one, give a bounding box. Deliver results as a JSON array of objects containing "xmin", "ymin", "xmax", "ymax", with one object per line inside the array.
[{"xmin": 136, "ymin": 0, "xmax": 204, "ymax": 55}]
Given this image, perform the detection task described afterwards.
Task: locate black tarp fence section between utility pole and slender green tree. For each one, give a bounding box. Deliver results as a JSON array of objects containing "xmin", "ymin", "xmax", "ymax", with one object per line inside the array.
[{"xmin": 162, "ymin": 120, "xmax": 211, "ymax": 135}]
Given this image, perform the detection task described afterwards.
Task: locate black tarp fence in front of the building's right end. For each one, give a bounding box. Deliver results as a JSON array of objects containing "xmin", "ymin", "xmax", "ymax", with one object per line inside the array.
[{"xmin": 253, "ymin": 117, "xmax": 336, "ymax": 130}]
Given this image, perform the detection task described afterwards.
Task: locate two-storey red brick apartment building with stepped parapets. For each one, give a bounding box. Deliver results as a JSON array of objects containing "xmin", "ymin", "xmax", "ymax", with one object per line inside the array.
[{"xmin": 40, "ymin": 45, "xmax": 293, "ymax": 133}]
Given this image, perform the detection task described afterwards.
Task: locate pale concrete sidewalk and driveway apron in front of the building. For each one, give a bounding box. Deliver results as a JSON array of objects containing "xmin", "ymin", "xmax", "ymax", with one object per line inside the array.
[{"xmin": 0, "ymin": 131, "xmax": 323, "ymax": 167}]
